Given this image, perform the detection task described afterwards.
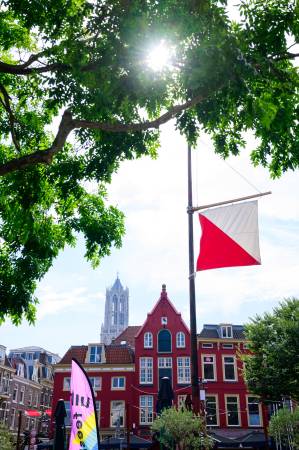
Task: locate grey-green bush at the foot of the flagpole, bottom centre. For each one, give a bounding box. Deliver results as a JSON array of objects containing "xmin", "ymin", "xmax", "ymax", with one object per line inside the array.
[{"xmin": 152, "ymin": 407, "xmax": 213, "ymax": 450}]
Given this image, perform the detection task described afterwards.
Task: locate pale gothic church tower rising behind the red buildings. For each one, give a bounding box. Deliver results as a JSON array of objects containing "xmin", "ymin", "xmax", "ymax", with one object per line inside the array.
[{"xmin": 101, "ymin": 275, "xmax": 129, "ymax": 345}]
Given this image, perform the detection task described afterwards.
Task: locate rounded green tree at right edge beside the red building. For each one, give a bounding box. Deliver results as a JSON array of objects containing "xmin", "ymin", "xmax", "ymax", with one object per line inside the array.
[{"xmin": 245, "ymin": 298, "xmax": 299, "ymax": 401}]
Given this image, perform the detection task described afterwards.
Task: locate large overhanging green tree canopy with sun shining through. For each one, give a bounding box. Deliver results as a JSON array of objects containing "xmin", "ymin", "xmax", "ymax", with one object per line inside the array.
[{"xmin": 0, "ymin": 0, "xmax": 299, "ymax": 323}]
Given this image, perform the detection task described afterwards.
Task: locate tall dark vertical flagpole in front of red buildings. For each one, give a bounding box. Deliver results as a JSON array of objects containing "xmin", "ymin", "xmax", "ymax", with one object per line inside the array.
[{"xmin": 187, "ymin": 144, "xmax": 199, "ymax": 414}]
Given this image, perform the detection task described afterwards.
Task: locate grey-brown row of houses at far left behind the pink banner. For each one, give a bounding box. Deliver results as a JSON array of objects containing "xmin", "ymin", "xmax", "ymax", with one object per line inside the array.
[{"xmin": 0, "ymin": 345, "xmax": 60, "ymax": 435}]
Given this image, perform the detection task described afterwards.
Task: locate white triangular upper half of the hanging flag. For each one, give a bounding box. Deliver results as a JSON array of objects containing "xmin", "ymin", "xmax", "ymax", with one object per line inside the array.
[{"xmin": 200, "ymin": 200, "xmax": 261, "ymax": 262}]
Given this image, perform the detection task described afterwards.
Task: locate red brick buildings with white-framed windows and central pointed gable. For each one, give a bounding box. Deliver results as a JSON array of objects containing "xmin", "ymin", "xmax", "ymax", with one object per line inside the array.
[{"xmin": 53, "ymin": 287, "xmax": 263, "ymax": 443}]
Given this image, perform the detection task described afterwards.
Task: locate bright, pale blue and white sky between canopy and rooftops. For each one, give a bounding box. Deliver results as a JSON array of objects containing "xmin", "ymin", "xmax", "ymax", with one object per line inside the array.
[{"xmin": 0, "ymin": 122, "xmax": 299, "ymax": 356}]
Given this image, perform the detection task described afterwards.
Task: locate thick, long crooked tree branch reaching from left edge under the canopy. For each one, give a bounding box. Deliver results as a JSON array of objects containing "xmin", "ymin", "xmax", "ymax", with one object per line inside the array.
[{"xmin": 0, "ymin": 95, "xmax": 206, "ymax": 176}]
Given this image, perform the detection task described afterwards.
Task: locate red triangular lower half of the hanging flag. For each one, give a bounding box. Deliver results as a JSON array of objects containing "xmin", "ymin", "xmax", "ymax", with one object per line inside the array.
[{"xmin": 196, "ymin": 214, "xmax": 260, "ymax": 271}]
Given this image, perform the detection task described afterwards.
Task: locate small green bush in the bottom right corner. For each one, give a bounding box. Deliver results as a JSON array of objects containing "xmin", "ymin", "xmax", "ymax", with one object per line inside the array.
[{"xmin": 269, "ymin": 408, "xmax": 299, "ymax": 450}]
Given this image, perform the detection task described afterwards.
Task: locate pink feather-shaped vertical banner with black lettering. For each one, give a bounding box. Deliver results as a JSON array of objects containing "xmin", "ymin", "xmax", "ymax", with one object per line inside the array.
[{"xmin": 69, "ymin": 359, "xmax": 99, "ymax": 450}]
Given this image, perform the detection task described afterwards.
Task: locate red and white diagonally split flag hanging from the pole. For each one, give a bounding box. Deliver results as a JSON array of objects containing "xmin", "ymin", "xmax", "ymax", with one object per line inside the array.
[{"xmin": 196, "ymin": 200, "xmax": 261, "ymax": 271}]
